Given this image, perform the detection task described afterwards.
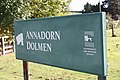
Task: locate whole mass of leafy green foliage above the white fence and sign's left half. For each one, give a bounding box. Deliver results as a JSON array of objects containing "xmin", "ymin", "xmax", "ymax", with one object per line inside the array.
[{"xmin": 0, "ymin": 0, "xmax": 71, "ymax": 36}]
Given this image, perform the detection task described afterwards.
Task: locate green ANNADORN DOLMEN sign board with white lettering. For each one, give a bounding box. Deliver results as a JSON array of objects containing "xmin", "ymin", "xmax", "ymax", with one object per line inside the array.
[{"xmin": 14, "ymin": 13, "xmax": 107, "ymax": 76}]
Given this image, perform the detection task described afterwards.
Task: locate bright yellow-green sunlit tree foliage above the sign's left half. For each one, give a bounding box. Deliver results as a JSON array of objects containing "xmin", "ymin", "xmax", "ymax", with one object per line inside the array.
[{"xmin": 20, "ymin": 0, "xmax": 71, "ymax": 19}]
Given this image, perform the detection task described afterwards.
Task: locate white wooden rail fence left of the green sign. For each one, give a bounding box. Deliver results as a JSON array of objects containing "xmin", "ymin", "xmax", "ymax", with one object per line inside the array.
[{"xmin": 0, "ymin": 36, "xmax": 15, "ymax": 55}]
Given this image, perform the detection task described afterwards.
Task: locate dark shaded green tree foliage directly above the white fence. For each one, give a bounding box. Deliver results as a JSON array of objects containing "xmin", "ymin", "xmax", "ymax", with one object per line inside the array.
[{"xmin": 0, "ymin": 0, "xmax": 20, "ymax": 35}]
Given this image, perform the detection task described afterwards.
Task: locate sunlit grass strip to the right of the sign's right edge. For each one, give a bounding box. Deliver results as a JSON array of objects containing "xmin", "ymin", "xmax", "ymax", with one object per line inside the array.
[{"xmin": 107, "ymin": 29, "xmax": 120, "ymax": 80}]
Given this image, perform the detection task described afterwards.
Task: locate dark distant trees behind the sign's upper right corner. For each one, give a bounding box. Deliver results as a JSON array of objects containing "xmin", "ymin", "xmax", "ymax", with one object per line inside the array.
[{"xmin": 82, "ymin": 0, "xmax": 120, "ymax": 20}]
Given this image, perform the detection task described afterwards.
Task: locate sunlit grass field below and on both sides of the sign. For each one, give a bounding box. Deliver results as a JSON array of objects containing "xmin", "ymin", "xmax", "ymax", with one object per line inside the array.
[{"xmin": 0, "ymin": 29, "xmax": 120, "ymax": 80}]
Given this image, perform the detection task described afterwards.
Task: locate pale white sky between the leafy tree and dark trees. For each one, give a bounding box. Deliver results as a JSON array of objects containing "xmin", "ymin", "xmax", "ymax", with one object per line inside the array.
[{"xmin": 69, "ymin": 0, "xmax": 104, "ymax": 11}]
